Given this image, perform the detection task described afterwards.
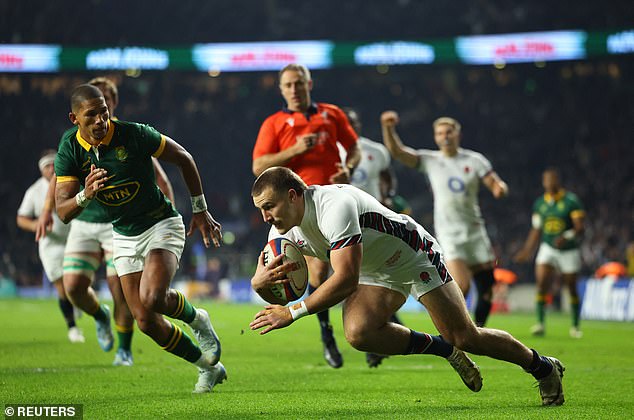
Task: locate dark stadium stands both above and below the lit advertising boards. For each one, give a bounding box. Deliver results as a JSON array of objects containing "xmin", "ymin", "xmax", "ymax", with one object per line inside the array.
[{"xmin": 0, "ymin": 0, "xmax": 634, "ymax": 285}]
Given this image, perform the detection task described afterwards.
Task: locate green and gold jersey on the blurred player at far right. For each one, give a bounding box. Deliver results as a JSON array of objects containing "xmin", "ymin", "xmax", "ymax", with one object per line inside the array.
[{"xmin": 533, "ymin": 190, "xmax": 585, "ymax": 250}]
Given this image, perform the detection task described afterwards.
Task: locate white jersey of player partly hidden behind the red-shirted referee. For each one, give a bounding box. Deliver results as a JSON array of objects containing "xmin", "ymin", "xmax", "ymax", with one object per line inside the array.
[{"xmin": 350, "ymin": 137, "xmax": 390, "ymax": 200}]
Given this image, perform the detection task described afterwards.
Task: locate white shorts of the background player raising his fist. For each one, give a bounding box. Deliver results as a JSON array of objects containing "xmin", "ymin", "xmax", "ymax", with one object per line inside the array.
[{"xmin": 436, "ymin": 227, "xmax": 495, "ymax": 266}]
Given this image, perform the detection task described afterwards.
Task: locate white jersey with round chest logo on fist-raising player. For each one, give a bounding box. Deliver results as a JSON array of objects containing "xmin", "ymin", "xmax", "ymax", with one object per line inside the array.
[{"xmin": 417, "ymin": 148, "xmax": 493, "ymax": 236}]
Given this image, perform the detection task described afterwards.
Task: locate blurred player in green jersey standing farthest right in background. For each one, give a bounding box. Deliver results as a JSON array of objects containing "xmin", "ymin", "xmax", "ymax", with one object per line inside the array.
[{"xmin": 515, "ymin": 168, "xmax": 585, "ymax": 338}]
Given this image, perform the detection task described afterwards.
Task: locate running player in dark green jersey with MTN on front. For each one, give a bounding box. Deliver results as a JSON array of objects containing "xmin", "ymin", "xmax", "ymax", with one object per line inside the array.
[{"xmin": 55, "ymin": 84, "xmax": 226, "ymax": 392}]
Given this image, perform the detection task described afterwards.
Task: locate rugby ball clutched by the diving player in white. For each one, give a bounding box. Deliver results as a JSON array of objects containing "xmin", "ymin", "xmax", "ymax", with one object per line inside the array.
[{"xmin": 262, "ymin": 238, "xmax": 308, "ymax": 304}]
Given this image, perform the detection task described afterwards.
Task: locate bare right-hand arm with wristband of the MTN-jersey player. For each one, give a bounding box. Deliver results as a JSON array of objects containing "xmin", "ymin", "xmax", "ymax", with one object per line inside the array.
[{"xmin": 158, "ymin": 136, "xmax": 222, "ymax": 247}]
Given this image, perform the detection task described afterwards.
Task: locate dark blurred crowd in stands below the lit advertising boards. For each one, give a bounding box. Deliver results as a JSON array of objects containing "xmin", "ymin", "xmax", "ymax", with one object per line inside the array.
[{"xmin": 0, "ymin": 55, "xmax": 634, "ymax": 285}]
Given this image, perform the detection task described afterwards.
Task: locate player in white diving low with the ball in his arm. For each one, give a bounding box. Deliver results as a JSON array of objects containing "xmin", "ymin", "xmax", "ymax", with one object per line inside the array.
[{"xmin": 250, "ymin": 167, "xmax": 564, "ymax": 405}]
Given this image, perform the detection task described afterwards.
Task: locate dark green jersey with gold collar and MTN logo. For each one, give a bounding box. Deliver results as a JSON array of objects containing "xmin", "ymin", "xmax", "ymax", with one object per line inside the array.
[{"xmin": 55, "ymin": 120, "xmax": 178, "ymax": 236}]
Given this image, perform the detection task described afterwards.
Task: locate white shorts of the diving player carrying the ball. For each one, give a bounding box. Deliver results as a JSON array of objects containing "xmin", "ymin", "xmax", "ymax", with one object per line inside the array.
[{"xmin": 359, "ymin": 231, "xmax": 452, "ymax": 300}]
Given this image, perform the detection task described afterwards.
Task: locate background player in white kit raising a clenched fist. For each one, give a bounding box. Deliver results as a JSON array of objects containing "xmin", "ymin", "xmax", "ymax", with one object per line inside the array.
[{"xmin": 381, "ymin": 111, "xmax": 508, "ymax": 327}]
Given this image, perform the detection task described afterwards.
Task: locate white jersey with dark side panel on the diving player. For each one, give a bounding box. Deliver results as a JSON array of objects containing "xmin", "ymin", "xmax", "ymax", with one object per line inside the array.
[{"xmin": 269, "ymin": 184, "xmax": 448, "ymax": 280}]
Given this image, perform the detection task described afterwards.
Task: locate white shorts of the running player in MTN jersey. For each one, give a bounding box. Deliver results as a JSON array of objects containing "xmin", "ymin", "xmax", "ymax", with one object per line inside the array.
[{"xmin": 112, "ymin": 216, "xmax": 185, "ymax": 276}]
